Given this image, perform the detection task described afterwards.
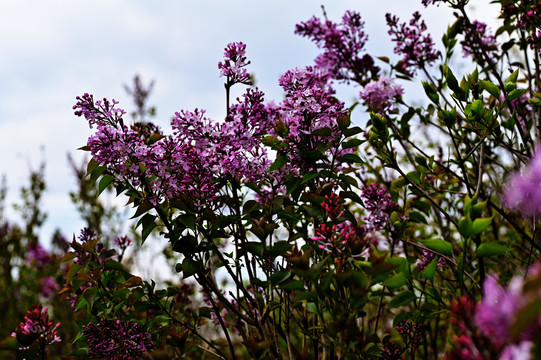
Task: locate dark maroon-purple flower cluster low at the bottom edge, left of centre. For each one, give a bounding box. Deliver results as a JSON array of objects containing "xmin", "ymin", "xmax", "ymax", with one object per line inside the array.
[{"xmin": 82, "ymin": 319, "xmax": 152, "ymax": 360}]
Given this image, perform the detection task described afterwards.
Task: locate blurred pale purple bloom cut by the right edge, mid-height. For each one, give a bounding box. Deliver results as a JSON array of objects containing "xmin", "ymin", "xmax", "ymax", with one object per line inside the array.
[{"xmin": 503, "ymin": 146, "xmax": 541, "ymax": 216}]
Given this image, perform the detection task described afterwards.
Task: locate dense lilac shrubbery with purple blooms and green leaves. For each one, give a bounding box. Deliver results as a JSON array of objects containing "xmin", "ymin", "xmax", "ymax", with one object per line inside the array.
[{"xmin": 0, "ymin": 0, "xmax": 541, "ymax": 359}]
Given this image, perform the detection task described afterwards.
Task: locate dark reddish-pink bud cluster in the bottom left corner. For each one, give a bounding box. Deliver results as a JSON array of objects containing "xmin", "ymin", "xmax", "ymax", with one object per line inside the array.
[{"xmin": 11, "ymin": 305, "xmax": 61, "ymax": 349}]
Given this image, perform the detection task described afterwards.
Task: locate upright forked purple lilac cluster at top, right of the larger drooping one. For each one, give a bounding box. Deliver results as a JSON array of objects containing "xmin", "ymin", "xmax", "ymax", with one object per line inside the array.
[{"xmin": 385, "ymin": 11, "xmax": 439, "ymax": 76}]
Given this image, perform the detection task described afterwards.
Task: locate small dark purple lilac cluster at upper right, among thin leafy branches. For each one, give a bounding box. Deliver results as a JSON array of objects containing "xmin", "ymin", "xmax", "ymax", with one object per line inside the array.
[{"xmin": 460, "ymin": 20, "xmax": 498, "ymax": 62}]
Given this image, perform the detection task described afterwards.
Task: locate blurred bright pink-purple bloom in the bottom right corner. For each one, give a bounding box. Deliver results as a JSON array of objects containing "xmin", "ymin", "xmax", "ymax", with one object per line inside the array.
[{"xmin": 475, "ymin": 276, "xmax": 522, "ymax": 346}]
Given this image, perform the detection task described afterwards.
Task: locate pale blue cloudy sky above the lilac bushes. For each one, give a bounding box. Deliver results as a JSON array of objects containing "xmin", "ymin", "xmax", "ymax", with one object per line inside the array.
[{"xmin": 0, "ymin": 0, "xmax": 497, "ymax": 268}]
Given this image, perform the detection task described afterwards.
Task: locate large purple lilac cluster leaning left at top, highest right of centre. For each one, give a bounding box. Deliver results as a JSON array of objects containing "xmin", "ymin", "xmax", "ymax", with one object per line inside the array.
[{"xmin": 295, "ymin": 11, "xmax": 379, "ymax": 83}]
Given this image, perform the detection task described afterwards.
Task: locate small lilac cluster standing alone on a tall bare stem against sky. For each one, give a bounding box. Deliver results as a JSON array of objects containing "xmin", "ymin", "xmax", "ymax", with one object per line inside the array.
[{"xmin": 218, "ymin": 42, "xmax": 252, "ymax": 87}]
